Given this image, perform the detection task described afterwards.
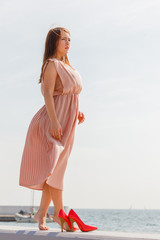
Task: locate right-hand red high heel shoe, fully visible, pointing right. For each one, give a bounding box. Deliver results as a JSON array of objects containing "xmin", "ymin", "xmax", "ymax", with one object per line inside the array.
[{"xmin": 68, "ymin": 209, "xmax": 98, "ymax": 232}]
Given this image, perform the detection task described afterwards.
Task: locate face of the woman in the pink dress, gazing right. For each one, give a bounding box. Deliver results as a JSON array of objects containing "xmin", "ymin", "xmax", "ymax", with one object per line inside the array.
[{"xmin": 57, "ymin": 31, "xmax": 71, "ymax": 55}]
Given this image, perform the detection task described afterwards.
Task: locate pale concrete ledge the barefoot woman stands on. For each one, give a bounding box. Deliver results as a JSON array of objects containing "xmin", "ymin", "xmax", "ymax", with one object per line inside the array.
[{"xmin": 0, "ymin": 225, "xmax": 160, "ymax": 240}]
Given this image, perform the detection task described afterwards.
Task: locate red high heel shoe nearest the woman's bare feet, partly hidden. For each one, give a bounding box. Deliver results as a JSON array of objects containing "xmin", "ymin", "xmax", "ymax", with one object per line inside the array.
[{"xmin": 58, "ymin": 209, "xmax": 79, "ymax": 232}]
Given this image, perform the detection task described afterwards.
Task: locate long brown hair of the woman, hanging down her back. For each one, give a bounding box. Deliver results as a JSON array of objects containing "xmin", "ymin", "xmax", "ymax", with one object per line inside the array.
[{"xmin": 38, "ymin": 27, "xmax": 70, "ymax": 83}]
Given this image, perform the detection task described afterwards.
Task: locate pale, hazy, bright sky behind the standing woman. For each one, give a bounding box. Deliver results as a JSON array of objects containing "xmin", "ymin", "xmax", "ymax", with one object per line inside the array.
[{"xmin": 0, "ymin": 0, "xmax": 160, "ymax": 209}]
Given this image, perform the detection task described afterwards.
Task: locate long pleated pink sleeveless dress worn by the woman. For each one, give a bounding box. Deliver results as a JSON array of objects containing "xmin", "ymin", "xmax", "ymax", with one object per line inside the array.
[{"xmin": 19, "ymin": 58, "xmax": 82, "ymax": 190}]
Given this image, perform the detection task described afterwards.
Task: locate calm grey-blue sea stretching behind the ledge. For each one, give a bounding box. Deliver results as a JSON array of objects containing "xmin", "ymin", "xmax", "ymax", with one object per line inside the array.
[{"xmin": 0, "ymin": 208, "xmax": 160, "ymax": 234}]
